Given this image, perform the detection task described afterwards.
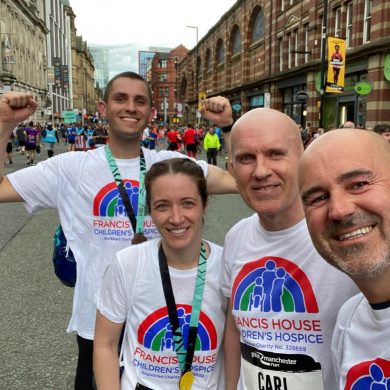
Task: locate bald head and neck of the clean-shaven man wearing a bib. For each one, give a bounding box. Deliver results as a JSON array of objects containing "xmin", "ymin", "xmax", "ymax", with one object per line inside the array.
[{"xmin": 231, "ymin": 109, "xmax": 303, "ymax": 230}]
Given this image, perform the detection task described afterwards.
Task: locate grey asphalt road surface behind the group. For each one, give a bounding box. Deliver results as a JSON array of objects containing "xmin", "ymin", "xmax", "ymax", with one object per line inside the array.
[{"xmin": 0, "ymin": 145, "xmax": 251, "ymax": 390}]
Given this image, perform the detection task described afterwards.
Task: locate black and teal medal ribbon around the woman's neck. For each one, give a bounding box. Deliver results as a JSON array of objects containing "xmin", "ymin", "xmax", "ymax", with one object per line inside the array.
[{"xmin": 158, "ymin": 241, "xmax": 207, "ymax": 374}]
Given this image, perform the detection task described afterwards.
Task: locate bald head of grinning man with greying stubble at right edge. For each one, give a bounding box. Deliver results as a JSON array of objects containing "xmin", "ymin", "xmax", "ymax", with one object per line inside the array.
[{"xmin": 299, "ymin": 129, "xmax": 390, "ymax": 279}]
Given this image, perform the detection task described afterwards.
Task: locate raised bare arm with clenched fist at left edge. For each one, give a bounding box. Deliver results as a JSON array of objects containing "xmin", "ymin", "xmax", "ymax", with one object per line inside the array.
[{"xmin": 0, "ymin": 92, "xmax": 38, "ymax": 203}]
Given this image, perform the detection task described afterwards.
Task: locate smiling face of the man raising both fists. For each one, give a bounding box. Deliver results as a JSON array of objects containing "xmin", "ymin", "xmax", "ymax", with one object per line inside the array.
[{"xmin": 99, "ymin": 77, "xmax": 154, "ymax": 141}]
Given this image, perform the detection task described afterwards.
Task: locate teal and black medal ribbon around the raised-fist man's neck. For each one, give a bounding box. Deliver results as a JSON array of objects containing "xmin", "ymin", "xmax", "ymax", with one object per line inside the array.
[{"xmin": 104, "ymin": 144, "xmax": 146, "ymax": 234}]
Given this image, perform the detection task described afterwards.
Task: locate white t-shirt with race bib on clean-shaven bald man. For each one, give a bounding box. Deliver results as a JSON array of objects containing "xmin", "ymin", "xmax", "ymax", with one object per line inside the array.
[{"xmin": 222, "ymin": 214, "xmax": 357, "ymax": 390}]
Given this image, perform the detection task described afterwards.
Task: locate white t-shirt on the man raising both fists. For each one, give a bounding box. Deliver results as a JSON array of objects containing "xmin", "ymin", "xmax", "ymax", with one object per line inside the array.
[{"xmin": 8, "ymin": 148, "xmax": 208, "ymax": 340}]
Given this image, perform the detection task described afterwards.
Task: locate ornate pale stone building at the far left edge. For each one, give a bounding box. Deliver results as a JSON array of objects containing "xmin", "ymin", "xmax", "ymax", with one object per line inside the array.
[{"xmin": 0, "ymin": 0, "xmax": 48, "ymax": 123}]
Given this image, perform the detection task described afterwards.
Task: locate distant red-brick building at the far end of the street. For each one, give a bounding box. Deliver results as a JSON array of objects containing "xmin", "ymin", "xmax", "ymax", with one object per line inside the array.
[{"xmin": 151, "ymin": 45, "xmax": 188, "ymax": 122}]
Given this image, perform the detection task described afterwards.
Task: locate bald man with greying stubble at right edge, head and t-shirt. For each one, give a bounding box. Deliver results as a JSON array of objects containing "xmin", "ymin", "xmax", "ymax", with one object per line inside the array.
[{"xmin": 299, "ymin": 129, "xmax": 390, "ymax": 390}]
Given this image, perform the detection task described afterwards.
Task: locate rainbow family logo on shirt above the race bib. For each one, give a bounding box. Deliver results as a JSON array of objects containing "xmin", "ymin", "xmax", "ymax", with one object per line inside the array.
[{"xmin": 232, "ymin": 256, "xmax": 318, "ymax": 313}]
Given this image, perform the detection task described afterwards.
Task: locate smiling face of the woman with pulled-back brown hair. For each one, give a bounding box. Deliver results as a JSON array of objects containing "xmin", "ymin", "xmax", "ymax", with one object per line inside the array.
[{"xmin": 150, "ymin": 173, "xmax": 206, "ymax": 251}]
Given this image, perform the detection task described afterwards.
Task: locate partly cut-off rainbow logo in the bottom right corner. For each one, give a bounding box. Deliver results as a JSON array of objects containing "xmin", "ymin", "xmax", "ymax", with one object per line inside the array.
[{"xmin": 344, "ymin": 358, "xmax": 390, "ymax": 390}]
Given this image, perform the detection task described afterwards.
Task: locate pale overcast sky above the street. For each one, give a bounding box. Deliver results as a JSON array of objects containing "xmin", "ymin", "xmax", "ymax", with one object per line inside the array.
[{"xmin": 70, "ymin": 0, "xmax": 236, "ymax": 77}]
